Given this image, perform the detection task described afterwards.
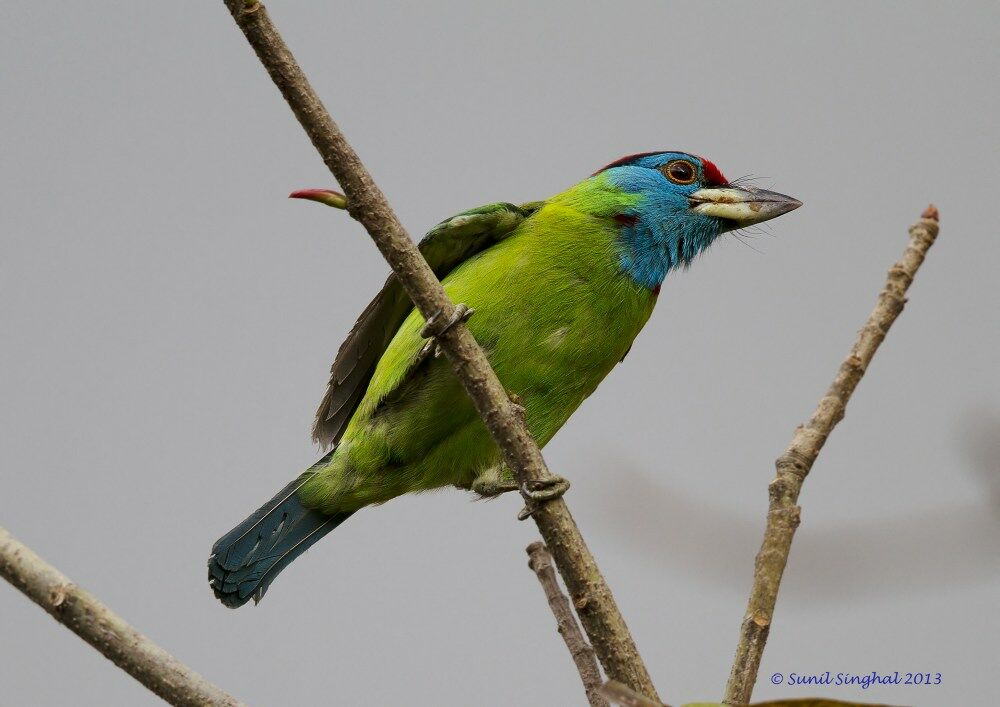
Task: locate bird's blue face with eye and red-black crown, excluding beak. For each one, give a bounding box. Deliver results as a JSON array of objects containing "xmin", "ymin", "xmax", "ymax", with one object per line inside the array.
[{"xmin": 601, "ymin": 152, "xmax": 732, "ymax": 289}]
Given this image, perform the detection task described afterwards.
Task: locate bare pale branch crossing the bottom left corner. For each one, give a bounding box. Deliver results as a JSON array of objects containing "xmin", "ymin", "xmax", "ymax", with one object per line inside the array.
[{"xmin": 0, "ymin": 528, "xmax": 243, "ymax": 707}]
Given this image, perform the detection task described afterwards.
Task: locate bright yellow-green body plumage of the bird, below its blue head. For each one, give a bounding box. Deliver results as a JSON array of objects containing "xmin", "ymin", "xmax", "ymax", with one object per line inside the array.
[{"xmin": 299, "ymin": 178, "xmax": 656, "ymax": 513}]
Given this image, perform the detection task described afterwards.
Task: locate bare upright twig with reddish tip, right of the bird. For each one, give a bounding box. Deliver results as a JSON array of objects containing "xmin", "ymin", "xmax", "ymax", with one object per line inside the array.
[{"xmin": 723, "ymin": 205, "xmax": 938, "ymax": 705}]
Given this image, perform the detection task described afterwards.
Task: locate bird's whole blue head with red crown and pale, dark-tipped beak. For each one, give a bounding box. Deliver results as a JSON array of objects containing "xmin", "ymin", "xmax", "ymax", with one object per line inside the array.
[{"xmin": 587, "ymin": 152, "xmax": 802, "ymax": 289}]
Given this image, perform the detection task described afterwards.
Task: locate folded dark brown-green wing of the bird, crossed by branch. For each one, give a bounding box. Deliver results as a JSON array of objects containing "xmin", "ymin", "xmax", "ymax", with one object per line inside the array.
[{"xmin": 313, "ymin": 202, "xmax": 542, "ymax": 446}]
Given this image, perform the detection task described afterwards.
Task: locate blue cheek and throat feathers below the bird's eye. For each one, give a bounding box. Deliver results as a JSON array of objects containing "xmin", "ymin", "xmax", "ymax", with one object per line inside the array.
[{"xmin": 607, "ymin": 166, "xmax": 722, "ymax": 290}]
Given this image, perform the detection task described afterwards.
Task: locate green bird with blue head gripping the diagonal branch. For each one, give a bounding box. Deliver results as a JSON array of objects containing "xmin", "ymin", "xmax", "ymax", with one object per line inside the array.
[{"xmin": 208, "ymin": 152, "xmax": 801, "ymax": 607}]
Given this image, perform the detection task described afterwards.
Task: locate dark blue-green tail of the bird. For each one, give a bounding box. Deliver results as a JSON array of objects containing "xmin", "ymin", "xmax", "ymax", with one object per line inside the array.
[{"xmin": 208, "ymin": 460, "xmax": 351, "ymax": 609}]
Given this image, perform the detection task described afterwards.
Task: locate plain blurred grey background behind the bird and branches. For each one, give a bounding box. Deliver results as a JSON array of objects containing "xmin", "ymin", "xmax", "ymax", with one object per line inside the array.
[{"xmin": 0, "ymin": 2, "xmax": 1000, "ymax": 705}]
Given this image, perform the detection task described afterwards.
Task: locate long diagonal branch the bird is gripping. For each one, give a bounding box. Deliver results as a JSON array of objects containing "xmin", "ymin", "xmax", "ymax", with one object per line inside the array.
[{"xmin": 225, "ymin": 0, "xmax": 656, "ymax": 697}]
